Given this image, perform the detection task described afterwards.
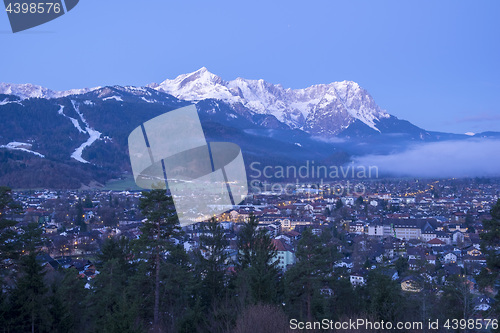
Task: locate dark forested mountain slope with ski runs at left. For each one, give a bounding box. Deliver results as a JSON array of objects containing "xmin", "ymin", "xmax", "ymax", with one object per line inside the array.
[{"xmin": 0, "ymin": 87, "xmax": 188, "ymax": 189}]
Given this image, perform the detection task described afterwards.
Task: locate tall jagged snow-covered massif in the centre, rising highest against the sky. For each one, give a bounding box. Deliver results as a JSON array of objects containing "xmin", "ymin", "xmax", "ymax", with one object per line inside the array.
[{"xmin": 150, "ymin": 67, "xmax": 389, "ymax": 135}]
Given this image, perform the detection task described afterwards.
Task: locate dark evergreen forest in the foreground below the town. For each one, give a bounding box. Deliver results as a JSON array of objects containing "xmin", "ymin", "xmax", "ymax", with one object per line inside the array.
[{"xmin": 0, "ymin": 187, "xmax": 500, "ymax": 333}]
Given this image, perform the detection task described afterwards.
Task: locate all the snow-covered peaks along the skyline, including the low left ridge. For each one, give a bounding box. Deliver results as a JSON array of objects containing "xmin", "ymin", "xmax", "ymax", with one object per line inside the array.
[{"xmin": 0, "ymin": 67, "xmax": 390, "ymax": 136}]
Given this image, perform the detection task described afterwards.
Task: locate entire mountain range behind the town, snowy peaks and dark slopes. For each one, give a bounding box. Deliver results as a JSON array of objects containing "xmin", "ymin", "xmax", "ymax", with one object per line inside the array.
[{"xmin": 0, "ymin": 68, "xmax": 500, "ymax": 188}]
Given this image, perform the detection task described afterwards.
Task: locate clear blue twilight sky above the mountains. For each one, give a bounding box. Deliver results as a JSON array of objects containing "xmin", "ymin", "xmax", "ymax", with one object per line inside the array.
[{"xmin": 0, "ymin": 0, "xmax": 500, "ymax": 133}]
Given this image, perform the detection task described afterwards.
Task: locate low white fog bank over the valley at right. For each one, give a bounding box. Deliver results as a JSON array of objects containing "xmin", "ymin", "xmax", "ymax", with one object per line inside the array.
[{"xmin": 355, "ymin": 139, "xmax": 500, "ymax": 177}]
